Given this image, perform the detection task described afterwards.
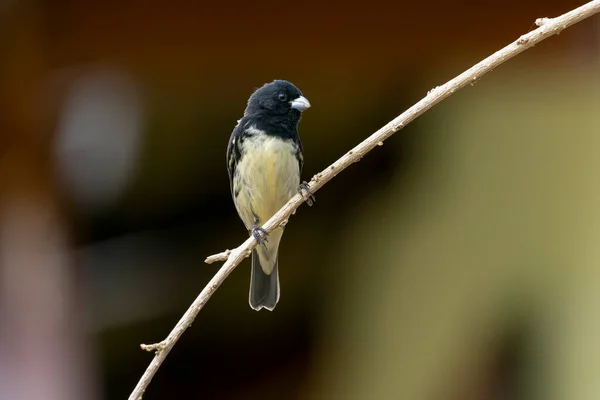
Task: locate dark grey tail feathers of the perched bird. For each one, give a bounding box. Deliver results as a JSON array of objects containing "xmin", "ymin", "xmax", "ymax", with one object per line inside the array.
[{"xmin": 250, "ymin": 250, "xmax": 279, "ymax": 311}]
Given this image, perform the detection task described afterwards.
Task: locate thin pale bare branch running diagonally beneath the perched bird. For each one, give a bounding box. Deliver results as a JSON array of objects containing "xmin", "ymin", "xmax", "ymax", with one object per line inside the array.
[{"xmin": 129, "ymin": 0, "xmax": 600, "ymax": 400}]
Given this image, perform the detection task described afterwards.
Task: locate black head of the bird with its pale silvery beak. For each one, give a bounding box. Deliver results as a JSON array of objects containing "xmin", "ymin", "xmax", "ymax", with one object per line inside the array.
[{"xmin": 245, "ymin": 80, "xmax": 310, "ymax": 121}]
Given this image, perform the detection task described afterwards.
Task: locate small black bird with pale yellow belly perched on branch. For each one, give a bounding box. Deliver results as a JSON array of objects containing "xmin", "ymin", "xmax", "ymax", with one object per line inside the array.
[{"xmin": 227, "ymin": 80, "xmax": 314, "ymax": 311}]
